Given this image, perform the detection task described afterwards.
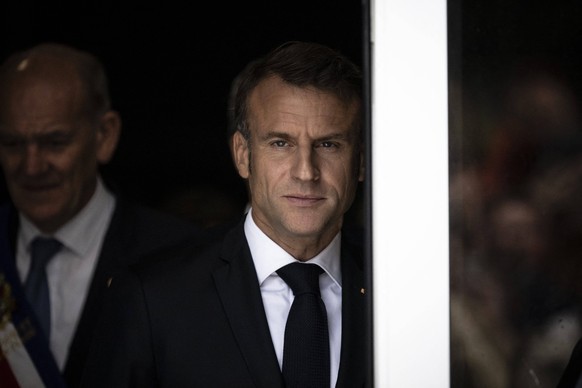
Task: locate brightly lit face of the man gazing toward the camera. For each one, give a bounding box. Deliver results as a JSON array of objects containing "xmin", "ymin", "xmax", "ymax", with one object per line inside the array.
[{"xmin": 235, "ymin": 77, "xmax": 364, "ymax": 259}]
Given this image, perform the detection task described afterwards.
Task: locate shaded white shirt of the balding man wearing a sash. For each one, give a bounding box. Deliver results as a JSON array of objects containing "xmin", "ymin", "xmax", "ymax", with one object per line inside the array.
[{"xmin": 16, "ymin": 180, "xmax": 115, "ymax": 370}]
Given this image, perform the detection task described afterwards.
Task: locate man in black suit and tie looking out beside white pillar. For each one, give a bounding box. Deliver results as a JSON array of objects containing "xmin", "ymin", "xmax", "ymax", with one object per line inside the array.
[{"xmin": 82, "ymin": 42, "xmax": 370, "ymax": 388}]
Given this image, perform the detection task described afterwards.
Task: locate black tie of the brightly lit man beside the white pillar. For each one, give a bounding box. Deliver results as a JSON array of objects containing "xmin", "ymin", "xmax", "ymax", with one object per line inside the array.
[{"xmin": 277, "ymin": 262, "xmax": 330, "ymax": 388}]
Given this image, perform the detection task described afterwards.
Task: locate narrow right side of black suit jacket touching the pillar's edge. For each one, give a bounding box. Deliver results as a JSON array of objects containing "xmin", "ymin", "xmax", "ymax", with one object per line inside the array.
[{"xmin": 337, "ymin": 236, "xmax": 371, "ymax": 387}]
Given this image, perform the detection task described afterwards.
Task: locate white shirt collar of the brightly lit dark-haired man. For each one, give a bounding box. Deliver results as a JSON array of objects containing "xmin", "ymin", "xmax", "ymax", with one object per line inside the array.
[{"xmin": 244, "ymin": 209, "xmax": 341, "ymax": 287}]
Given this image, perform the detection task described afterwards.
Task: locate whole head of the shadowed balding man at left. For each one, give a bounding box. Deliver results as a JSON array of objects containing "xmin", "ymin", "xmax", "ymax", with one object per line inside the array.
[{"xmin": 0, "ymin": 44, "xmax": 121, "ymax": 233}]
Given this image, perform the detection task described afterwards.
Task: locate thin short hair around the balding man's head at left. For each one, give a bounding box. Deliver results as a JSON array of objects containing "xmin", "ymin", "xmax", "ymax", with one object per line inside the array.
[{"xmin": 0, "ymin": 42, "xmax": 111, "ymax": 122}]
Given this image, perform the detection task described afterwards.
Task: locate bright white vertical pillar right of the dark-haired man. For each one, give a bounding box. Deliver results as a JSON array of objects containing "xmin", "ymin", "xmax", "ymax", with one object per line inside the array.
[{"xmin": 370, "ymin": 0, "xmax": 450, "ymax": 388}]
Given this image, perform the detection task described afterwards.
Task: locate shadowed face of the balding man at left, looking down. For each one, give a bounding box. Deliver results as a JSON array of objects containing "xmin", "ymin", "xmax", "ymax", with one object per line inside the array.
[{"xmin": 0, "ymin": 78, "xmax": 98, "ymax": 232}]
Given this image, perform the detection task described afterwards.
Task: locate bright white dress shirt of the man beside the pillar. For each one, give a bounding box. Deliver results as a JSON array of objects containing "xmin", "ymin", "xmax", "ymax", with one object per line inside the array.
[{"xmin": 245, "ymin": 209, "xmax": 342, "ymax": 387}]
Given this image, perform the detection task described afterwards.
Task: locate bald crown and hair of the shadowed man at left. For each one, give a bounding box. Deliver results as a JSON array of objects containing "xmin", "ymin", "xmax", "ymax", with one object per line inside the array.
[{"xmin": 0, "ymin": 43, "xmax": 111, "ymax": 120}]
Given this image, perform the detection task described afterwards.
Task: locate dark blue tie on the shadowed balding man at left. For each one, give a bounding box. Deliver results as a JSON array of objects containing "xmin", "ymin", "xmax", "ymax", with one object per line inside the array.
[{"xmin": 24, "ymin": 237, "xmax": 62, "ymax": 339}]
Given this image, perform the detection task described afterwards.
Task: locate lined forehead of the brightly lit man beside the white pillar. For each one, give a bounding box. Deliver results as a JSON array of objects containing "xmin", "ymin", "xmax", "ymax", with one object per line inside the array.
[{"xmin": 248, "ymin": 77, "xmax": 358, "ymax": 136}]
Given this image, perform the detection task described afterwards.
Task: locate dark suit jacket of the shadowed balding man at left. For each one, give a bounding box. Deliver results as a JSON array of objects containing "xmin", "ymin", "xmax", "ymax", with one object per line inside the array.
[{"xmin": 1, "ymin": 199, "xmax": 197, "ymax": 388}]
